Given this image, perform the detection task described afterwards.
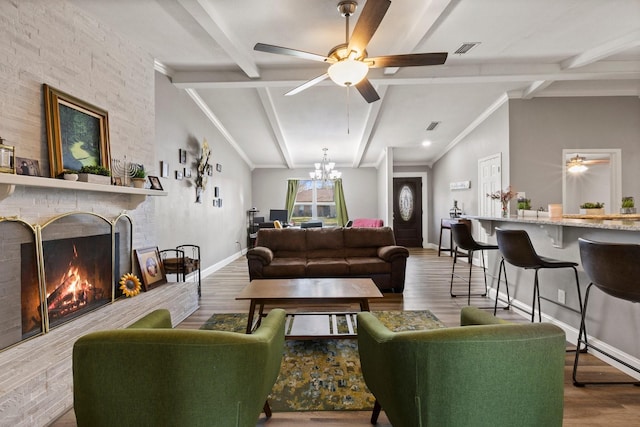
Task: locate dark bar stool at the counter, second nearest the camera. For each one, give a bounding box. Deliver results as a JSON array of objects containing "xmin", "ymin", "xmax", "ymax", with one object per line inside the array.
[{"xmin": 496, "ymin": 228, "xmax": 582, "ymax": 322}]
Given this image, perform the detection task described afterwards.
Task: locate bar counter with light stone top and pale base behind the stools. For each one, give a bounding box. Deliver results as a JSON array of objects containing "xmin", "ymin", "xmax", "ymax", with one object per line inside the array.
[{"xmin": 463, "ymin": 215, "xmax": 640, "ymax": 376}]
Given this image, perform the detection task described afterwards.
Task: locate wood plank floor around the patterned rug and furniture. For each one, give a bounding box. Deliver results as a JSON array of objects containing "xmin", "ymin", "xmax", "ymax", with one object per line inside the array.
[{"xmin": 52, "ymin": 249, "xmax": 640, "ymax": 427}]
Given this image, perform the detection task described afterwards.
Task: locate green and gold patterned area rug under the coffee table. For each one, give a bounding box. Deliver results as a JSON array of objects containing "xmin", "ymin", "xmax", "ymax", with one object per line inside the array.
[{"xmin": 200, "ymin": 310, "xmax": 444, "ymax": 412}]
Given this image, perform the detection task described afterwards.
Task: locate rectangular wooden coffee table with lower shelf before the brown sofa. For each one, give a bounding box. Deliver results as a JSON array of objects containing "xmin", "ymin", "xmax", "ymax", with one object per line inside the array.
[{"xmin": 236, "ymin": 278, "xmax": 382, "ymax": 339}]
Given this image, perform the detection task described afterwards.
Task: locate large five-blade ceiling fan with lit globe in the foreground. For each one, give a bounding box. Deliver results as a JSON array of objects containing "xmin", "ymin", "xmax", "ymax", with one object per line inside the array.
[{"xmin": 253, "ymin": 0, "xmax": 447, "ymax": 103}]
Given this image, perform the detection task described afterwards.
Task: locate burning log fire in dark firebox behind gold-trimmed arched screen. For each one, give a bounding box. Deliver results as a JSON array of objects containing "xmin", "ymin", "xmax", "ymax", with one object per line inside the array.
[{"xmin": 21, "ymin": 234, "xmax": 118, "ymax": 338}]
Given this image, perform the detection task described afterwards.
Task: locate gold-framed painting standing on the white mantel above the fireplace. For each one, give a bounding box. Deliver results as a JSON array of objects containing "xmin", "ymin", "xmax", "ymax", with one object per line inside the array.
[{"xmin": 43, "ymin": 84, "xmax": 111, "ymax": 177}]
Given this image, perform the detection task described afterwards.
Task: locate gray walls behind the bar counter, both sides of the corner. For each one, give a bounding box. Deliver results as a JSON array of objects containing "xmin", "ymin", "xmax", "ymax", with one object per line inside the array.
[{"xmin": 430, "ymin": 97, "xmax": 640, "ymax": 244}]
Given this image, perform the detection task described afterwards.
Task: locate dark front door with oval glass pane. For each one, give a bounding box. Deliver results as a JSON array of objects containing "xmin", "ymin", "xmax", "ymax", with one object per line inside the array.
[{"xmin": 393, "ymin": 177, "xmax": 422, "ymax": 248}]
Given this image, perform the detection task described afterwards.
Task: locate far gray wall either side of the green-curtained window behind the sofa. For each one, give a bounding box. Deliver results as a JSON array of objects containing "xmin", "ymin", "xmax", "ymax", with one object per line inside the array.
[{"xmin": 251, "ymin": 166, "xmax": 378, "ymax": 224}]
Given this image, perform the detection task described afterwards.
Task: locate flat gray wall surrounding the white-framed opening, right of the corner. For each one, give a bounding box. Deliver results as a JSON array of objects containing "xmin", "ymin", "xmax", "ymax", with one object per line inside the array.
[{"xmin": 509, "ymin": 96, "xmax": 640, "ymax": 211}]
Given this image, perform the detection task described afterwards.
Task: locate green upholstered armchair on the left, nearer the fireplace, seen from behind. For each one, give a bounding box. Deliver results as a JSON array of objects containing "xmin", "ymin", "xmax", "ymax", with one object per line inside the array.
[{"xmin": 73, "ymin": 309, "xmax": 285, "ymax": 427}]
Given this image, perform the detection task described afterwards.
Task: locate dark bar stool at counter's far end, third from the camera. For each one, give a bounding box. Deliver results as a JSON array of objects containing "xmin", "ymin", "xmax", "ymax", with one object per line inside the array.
[{"xmin": 449, "ymin": 222, "xmax": 509, "ymax": 309}]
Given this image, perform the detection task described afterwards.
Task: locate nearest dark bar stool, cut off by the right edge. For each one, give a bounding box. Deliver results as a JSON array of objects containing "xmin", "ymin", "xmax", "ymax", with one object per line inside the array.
[{"xmin": 573, "ymin": 238, "xmax": 640, "ymax": 387}]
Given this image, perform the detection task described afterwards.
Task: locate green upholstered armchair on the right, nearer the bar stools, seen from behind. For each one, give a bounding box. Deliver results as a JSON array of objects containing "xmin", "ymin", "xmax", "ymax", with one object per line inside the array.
[{"xmin": 358, "ymin": 307, "xmax": 565, "ymax": 427}]
